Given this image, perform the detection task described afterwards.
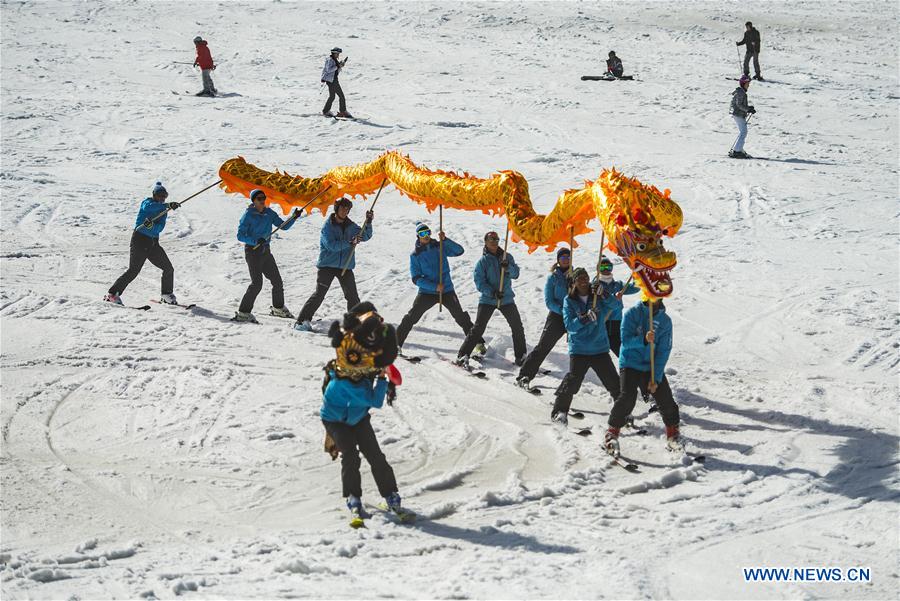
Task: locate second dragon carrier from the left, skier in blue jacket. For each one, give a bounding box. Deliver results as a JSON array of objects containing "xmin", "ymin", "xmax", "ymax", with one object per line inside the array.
[{"xmin": 233, "ymin": 189, "xmax": 301, "ymax": 323}]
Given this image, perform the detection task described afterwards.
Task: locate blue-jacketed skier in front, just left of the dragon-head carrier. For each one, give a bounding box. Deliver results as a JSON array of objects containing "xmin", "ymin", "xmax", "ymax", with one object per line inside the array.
[{"xmin": 550, "ymin": 267, "xmax": 619, "ymax": 425}]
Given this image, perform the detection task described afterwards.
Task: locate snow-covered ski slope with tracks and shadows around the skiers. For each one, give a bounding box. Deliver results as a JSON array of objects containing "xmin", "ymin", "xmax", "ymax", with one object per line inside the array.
[{"xmin": 0, "ymin": 2, "xmax": 900, "ymax": 599}]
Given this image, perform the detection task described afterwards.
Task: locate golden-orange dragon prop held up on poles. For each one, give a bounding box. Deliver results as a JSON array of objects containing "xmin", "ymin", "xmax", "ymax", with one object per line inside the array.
[{"xmin": 219, "ymin": 151, "xmax": 682, "ymax": 298}]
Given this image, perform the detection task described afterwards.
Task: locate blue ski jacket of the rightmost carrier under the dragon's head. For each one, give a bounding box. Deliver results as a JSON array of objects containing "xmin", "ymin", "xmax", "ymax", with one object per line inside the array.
[{"xmin": 619, "ymin": 302, "xmax": 672, "ymax": 382}]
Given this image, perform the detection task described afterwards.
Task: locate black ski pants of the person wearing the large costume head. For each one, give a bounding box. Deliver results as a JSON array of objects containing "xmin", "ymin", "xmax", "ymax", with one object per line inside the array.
[{"xmin": 322, "ymin": 415, "xmax": 397, "ymax": 498}]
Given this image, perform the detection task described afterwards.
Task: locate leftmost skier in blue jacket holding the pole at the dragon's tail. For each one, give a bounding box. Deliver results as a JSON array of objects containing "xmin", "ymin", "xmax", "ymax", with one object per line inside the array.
[{"xmin": 103, "ymin": 182, "xmax": 181, "ymax": 305}]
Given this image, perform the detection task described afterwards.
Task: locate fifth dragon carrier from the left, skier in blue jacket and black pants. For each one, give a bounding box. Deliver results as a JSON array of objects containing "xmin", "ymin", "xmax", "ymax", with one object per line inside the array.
[{"xmin": 456, "ymin": 232, "xmax": 526, "ymax": 366}]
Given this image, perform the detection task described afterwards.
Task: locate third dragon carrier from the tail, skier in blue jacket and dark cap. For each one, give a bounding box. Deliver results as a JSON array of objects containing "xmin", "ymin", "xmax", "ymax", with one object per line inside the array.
[{"xmin": 294, "ymin": 197, "xmax": 375, "ymax": 332}]
